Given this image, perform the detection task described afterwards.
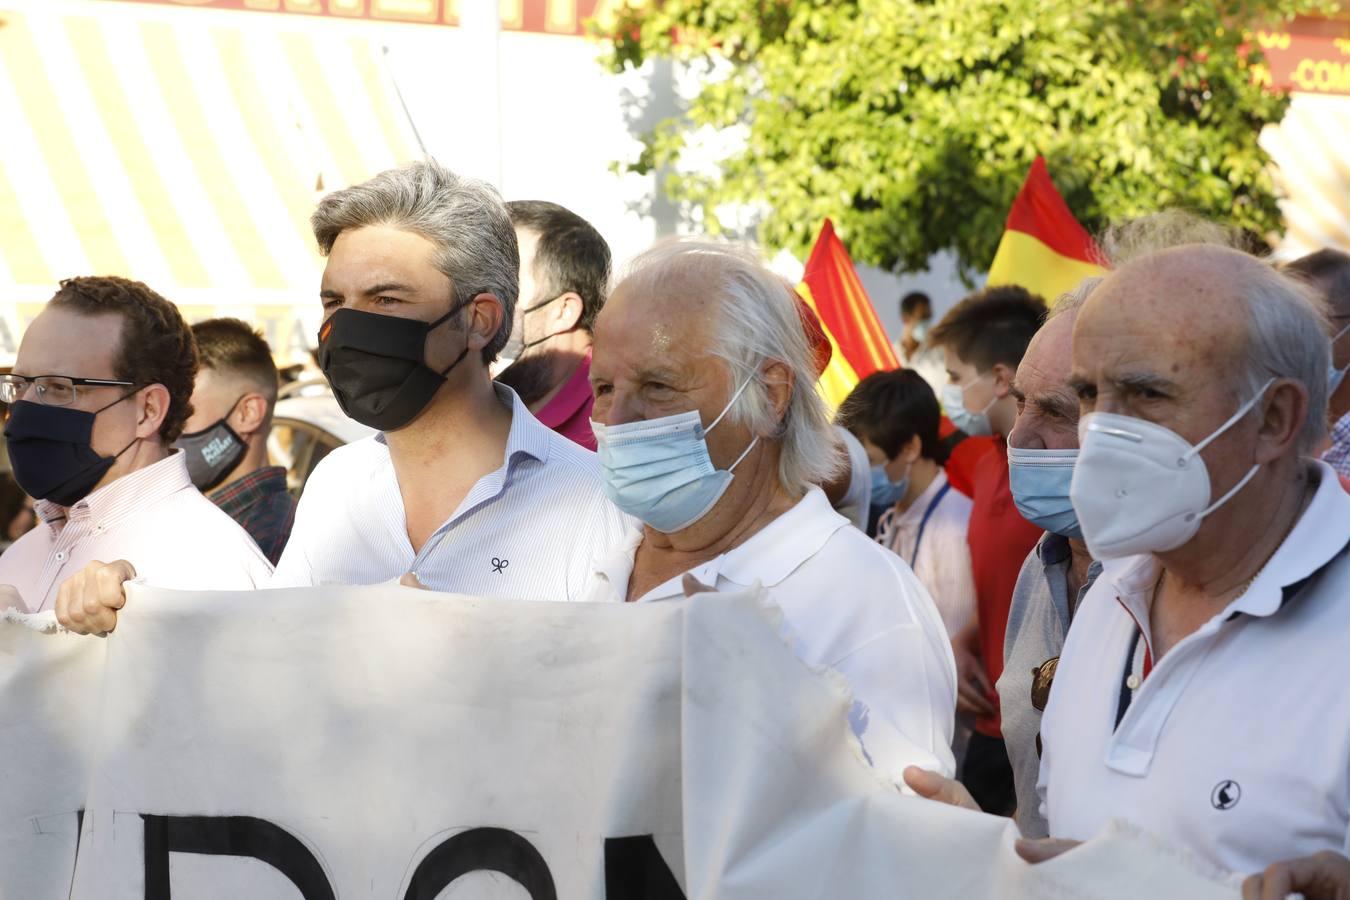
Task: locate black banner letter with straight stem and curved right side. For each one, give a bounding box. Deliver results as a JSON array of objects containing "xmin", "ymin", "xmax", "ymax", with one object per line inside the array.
[{"xmin": 140, "ymin": 814, "xmax": 335, "ymax": 900}]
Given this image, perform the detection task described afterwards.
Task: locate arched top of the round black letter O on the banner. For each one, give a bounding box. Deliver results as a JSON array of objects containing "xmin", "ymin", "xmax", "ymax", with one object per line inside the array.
[{"xmin": 404, "ymin": 828, "xmax": 558, "ymax": 900}]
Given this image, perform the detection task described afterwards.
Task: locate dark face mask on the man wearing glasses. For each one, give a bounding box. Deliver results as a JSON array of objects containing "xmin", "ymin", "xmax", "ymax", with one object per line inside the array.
[{"xmin": 4, "ymin": 391, "xmax": 140, "ymax": 506}]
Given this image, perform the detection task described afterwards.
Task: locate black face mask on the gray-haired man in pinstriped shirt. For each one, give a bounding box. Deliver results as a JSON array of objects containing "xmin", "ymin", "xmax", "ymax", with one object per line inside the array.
[{"xmin": 319, "ymin": 301, "xmax": 468, "ymax": 432}]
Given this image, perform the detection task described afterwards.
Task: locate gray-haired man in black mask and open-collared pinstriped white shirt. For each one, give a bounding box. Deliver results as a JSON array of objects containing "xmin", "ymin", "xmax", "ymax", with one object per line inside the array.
[{"xmin": 47, "ymin": 163, "xmax": 628, "ymax": 631}]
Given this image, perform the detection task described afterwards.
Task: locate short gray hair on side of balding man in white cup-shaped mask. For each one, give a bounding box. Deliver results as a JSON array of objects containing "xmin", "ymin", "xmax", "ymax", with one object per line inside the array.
[{"xmin": 1239, "ymin": 262, "xmax": 1331, "ymax": 456}]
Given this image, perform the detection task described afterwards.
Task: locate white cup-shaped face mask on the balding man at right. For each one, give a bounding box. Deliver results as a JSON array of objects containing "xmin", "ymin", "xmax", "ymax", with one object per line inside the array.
[{"xmin": 1069, "ymin": 378, "xmax": 1274, "ymax": 560}]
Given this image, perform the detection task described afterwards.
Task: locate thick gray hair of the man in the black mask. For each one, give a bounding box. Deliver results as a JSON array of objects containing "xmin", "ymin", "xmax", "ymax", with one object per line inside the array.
[{"xmin": 309, "ymin": 162, "xmax": 520, "ymax": 363}]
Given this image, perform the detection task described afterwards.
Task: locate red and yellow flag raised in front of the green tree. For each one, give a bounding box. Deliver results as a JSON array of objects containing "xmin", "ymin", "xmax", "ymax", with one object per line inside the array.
[{"xmin": 987, "ymin": 157, "xmax": 1104, "ymax": 302}]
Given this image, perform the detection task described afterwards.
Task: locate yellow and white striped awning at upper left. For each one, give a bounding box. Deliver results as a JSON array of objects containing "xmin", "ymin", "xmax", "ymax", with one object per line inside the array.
[{"xmin": 0, "ymin": 0, "xmax": 416, "ymax": 356}]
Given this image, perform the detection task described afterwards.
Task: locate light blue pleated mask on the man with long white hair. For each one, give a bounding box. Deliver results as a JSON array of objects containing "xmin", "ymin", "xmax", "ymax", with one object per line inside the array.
[{"xmin": 591, "ymin": 379, "xmax": 759, "ymax": 534}]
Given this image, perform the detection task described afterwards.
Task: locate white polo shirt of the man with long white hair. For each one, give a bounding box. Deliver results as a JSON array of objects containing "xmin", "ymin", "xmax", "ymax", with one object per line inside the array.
[{"xmin": 585, "ymin": 488, "xmax": 956, "ymax": 784}]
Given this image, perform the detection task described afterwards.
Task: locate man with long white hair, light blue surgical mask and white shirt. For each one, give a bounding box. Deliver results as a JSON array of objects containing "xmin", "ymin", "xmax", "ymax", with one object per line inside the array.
[{"xmin": 587, "ymin": 243, "xmax": 956, "ymax": 784}]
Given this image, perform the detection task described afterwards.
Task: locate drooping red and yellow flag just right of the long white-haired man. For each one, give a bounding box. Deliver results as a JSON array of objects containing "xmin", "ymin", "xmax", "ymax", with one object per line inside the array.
[{"xmin": 797, "ymin": 219, "xmax": 899, "ymax": 407}]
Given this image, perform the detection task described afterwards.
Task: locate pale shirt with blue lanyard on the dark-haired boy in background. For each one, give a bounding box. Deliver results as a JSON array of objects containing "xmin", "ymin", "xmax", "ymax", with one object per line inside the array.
[{"xmin": 876, "ymin": 470, "xmax": 975, "ymax": 636}]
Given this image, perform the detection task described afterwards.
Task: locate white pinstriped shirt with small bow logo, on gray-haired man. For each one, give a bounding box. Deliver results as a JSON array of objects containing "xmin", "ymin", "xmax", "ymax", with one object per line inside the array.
[{"xmin": 271, "ymin": 385, "xmax": 632, "ymax": 600}]
